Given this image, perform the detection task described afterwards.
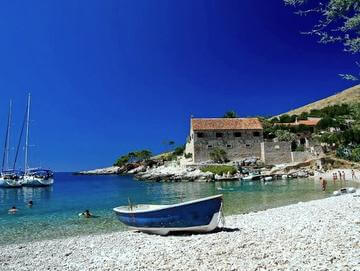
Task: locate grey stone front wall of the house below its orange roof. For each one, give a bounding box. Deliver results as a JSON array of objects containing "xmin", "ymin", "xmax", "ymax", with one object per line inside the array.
[{"xmin": 191, "ymin": 130, "xmax": 263, "ymax": 163}]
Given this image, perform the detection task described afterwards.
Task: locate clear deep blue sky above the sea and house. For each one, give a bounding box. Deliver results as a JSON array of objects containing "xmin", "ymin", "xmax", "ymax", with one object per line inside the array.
[{"xmin": 0, "ymin": 0, "xmax": 355, "ymax": 171}]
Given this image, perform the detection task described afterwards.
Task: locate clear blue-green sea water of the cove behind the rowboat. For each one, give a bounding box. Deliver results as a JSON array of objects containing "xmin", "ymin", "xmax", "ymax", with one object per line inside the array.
[{"xmin": 0, "ymin": 173, "xmax": 359, "ymax": 245}]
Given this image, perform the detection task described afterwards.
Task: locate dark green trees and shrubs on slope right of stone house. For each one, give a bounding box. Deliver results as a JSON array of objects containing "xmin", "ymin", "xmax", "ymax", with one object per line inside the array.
[{"xmin": 262, "ymin": 103, "xmax": 360, "ymax": 162}]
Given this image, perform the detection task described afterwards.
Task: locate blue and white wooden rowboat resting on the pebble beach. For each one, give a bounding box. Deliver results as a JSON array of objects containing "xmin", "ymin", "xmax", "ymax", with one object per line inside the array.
[{"xmin": 114, "ymin": 195, "xmax": 223, "ymax": 235}]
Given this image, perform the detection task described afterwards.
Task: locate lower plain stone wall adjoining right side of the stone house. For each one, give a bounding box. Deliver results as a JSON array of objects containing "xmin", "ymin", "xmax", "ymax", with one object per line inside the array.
[{"xmin": 261, "ymin": 142, "xmax": 292, "ymax": 165}]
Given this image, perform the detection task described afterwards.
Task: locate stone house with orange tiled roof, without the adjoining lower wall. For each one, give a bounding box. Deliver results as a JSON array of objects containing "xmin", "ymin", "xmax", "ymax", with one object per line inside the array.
[{"xmin": 185, "ymin": 118, "xmax": 264, "ymax": 163}]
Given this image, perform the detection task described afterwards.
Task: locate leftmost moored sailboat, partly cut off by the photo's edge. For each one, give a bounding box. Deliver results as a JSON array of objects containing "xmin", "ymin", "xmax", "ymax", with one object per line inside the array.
[{"xmin": 0, "ymin": 100, "xmax": 22, "ymax": 188}]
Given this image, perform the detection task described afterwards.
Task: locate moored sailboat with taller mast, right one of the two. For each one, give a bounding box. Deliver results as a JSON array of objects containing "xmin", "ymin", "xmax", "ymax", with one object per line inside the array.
[{"xmin": 22, "ymin": 93, "xmax": 54, "ymax": 187}]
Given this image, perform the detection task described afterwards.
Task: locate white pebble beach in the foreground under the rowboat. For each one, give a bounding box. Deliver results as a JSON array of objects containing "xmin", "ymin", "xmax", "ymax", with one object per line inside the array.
[{"xmin": 0, "ymin": 191, "xmax": 360, "ymax": 270}]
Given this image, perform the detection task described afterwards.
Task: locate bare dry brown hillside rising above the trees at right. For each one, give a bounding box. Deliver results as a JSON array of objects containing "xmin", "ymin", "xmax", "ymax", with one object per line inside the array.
[{"xmin": 281, "ymin": 85, "xmax": 360, "ymax": 115}]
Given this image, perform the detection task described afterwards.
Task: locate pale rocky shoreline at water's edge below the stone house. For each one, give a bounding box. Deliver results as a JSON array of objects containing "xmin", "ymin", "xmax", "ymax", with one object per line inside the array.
[{"xmin": 74, "ymin": 157, "xmax": 360, "ymax": 182}]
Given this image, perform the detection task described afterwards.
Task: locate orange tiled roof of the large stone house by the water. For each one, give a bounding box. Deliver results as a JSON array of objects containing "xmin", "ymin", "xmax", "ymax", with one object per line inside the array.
[{"xmin": 191, "ymin": 118, "xmax": 263, "ymax": 131}]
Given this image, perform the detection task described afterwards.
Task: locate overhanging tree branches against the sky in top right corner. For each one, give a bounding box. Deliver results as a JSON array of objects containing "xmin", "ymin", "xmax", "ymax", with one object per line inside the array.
[{"xmin": 284, "ymin": 0, "xmax": 360, "ymax": 80}]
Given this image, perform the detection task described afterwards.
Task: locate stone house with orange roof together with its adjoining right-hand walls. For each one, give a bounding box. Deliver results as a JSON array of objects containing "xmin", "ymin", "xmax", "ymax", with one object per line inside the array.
[{"xmin": 185, "ymin": 118, "xmax": 320, "ymax": 164}]
